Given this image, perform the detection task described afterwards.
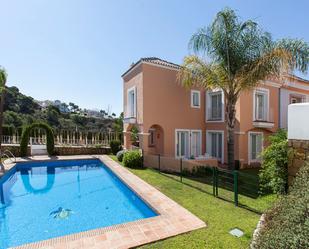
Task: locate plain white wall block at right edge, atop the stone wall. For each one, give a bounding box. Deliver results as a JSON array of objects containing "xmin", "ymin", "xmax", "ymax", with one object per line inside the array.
[{"xmin": 288, "ymin": 103, "xmax": 309, "ymax": 140}]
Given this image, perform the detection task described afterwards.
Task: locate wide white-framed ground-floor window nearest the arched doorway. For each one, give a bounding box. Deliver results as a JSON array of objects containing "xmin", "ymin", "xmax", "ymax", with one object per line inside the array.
[{"xmin": 175, "ymin": 130, "xmax": 202, "ymax": 158}]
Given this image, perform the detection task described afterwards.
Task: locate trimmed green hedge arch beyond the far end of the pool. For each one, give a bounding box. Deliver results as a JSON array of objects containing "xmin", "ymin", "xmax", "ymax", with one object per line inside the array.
[{"xmin": 20, "ymin": 123, "xmax": 55, "ymax": 156}]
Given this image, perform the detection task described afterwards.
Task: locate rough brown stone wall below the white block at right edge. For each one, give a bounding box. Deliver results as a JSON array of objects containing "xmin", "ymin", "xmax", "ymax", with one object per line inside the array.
[{"xmin": 288, "ymin": 139, "xmax": 309, "ymax": 184}]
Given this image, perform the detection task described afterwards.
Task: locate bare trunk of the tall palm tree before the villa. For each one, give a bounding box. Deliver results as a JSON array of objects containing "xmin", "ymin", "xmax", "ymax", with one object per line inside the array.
[{"xmin": 226, "ymin": 101, "xmax": 236, "ymax": 170}]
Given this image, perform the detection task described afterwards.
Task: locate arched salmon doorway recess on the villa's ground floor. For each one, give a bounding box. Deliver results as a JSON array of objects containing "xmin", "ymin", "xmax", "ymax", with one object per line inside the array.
[{"xmin": 148, "ymin": 125, "xmax": 164, "ymax": 155}]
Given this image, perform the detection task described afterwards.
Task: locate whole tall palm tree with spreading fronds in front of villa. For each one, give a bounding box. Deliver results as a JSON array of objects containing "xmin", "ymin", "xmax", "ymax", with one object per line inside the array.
[{"xmin": 179, "ymin": 8, "xmax": 309, "ymax": 168}]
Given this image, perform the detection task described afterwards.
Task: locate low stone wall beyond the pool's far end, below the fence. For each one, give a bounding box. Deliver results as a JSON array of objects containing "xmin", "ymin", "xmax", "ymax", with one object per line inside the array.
[{"xmin": 1, "ymin": 145, "xmax": 110, "ymax": 157}]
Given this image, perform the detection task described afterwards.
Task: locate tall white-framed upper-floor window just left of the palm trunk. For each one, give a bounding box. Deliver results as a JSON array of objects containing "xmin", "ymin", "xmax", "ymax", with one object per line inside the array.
[{"xmin": 207, "ymin": 91, "xmax": 223, "ymax": 121}]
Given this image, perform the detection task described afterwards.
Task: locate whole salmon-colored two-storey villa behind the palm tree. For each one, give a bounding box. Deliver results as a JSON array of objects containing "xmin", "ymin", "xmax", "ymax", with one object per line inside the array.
[{"xmin": 122, "ymin": 57, "xmax": 309, "ymax": 168}]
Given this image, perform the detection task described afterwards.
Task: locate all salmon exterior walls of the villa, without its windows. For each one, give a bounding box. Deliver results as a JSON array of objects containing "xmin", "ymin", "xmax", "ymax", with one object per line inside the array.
[{"xmin": 124, "ymin": 60, "xmax": 309, "ymax": 167}]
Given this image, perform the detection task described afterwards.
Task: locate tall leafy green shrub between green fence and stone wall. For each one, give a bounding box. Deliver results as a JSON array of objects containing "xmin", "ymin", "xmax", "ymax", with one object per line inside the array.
[{"xmin": 259, "ymin": 130, "xmax": 288, "ymax": 194}]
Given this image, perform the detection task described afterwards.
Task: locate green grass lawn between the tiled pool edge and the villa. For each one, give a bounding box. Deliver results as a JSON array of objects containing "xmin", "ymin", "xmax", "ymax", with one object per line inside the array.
[{"xmin": 111, "ymin": 156, "xmax": 273, "ymax": 249}]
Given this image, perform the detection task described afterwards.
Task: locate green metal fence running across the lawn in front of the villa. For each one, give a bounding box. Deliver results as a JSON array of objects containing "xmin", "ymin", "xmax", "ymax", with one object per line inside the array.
[{"xmin": 150, "ymin": 155, "xmax": 274, "ymax": 213}]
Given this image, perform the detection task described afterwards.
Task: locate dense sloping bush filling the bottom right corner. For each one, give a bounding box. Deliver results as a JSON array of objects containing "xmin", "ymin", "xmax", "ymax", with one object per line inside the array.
[{"xmin": 253, "ymin": 164, "xmax": 309, "ymax": 249}]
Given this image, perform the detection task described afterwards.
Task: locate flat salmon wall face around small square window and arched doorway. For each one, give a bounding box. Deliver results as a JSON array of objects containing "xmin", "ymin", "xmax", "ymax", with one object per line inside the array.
[{"xmin": 143, "ymin": 64, "xmax": 205, "ymax": 157}]
